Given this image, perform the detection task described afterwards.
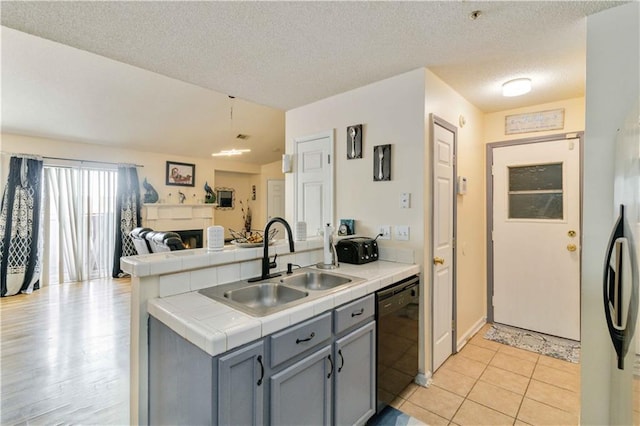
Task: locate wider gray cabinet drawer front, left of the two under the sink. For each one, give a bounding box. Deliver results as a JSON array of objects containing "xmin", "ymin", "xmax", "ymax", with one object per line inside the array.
[{"xmin": 270, "ymin": 312, "xmax": 331, "ymax": 367}]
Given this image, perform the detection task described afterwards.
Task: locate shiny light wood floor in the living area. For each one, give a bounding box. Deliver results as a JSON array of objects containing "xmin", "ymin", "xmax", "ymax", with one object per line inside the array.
[{"xmin": 0, "ymin": 279, "xmax": 130, "ymax": 425}]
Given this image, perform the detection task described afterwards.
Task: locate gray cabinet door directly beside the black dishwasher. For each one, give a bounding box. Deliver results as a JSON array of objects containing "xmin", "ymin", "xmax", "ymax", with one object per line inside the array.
[{"xmin": 335, "ymin": 321, "xmax": 376, "ymax": 425}]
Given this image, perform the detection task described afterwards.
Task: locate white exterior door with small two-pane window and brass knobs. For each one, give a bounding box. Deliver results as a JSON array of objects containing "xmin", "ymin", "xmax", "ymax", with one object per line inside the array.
[{"xmin": 492, "ymin": 139, "xmax": 580, "ymax": 340}]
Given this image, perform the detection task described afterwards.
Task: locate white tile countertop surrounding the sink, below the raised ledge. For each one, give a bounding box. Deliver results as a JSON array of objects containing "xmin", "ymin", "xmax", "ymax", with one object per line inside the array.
[{"xmin": 147, "ymin": 261, "xmax": 420, "ymax": 356}]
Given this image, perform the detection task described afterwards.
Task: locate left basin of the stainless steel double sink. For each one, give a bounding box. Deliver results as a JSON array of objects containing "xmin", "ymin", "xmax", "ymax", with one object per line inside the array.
[{"xmin": 224, "ymin": 282, "xmax": 309, "ymax": 308}]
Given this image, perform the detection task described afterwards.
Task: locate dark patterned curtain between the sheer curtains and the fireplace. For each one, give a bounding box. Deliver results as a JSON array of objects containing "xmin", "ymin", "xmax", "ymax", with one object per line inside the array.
[{"xmin": 112, "ymin": 166, "xmax": 142, "ymax": 278}]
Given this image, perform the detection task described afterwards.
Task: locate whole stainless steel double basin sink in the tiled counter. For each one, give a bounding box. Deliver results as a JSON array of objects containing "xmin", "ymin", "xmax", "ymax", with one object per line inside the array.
[{"xmin": 199, "ymin": 268, "xmax": 364, "ymax": 317}]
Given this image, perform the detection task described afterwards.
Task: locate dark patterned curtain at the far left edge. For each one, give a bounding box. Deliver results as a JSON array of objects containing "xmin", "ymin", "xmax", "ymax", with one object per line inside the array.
[{"xmin": 0, "ymin": 157, "xmax": 42, "ymax": 296}]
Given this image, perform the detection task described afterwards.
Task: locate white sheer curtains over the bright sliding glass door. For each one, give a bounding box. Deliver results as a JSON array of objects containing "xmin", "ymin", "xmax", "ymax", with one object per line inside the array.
[{"xmin": 43, "ymin": 166, "xmax": 116, "ymax": 284}]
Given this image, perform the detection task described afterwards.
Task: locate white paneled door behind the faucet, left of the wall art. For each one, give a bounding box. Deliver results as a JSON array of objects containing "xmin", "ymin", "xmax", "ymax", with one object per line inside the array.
[{"xmin": 295, "ymin": 131, "xmax": 335, "ymax": 236}]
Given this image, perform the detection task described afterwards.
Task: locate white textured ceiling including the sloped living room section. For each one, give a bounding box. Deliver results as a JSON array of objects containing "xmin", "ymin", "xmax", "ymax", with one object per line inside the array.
[{"xmin": 1, "ymin": 1, "xmax": 623, "ymax": 164}]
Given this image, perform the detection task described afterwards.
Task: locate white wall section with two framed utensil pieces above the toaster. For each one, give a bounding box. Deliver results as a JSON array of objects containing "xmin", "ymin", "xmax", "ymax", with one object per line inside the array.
[{"xmin": 286, "ymin": 69, "xmax": 425, "ymax": 253}]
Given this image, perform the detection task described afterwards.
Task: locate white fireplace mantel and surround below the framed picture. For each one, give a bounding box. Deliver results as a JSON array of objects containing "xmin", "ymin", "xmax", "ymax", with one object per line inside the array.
[{"xmin": 142, "ymin": 203, "xmax": 216, "ymax": 247}]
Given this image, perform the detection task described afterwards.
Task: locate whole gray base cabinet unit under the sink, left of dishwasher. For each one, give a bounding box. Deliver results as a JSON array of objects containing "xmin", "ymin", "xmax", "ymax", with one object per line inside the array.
[{"xmin": 149, "ymin": 296, "xmax": 376, "ymax": 426}]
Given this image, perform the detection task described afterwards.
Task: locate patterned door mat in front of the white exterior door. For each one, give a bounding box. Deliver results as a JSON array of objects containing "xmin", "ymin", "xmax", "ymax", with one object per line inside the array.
[{"xmin": 484, "ymin": 324, "xmax": 580, "ymax": 364}]
